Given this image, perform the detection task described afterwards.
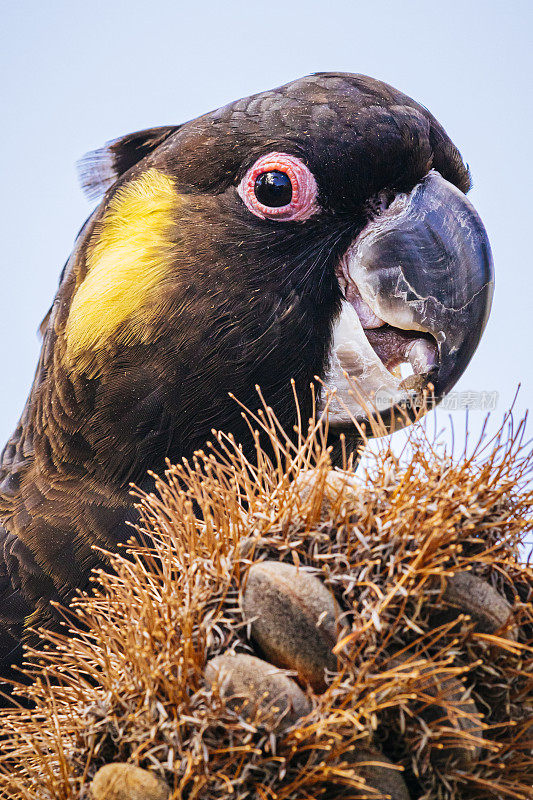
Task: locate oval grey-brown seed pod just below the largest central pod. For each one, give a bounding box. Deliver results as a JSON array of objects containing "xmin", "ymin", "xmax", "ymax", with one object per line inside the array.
[{"xmin": 204, "ymin": 653, "xmax": 311, "ymax": 729}]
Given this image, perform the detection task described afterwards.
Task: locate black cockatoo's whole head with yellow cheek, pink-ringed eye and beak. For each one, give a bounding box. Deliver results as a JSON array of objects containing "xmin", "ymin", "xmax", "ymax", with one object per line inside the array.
[{"xmin": 60, "ymin": 73, "xmax": 493, "ymax": 476}]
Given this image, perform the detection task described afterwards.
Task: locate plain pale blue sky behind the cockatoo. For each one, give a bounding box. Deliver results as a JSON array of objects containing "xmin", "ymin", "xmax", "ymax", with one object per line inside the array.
[{"xmin": 0, "ymin": 0, "xmax": 533, "ymax": 548}]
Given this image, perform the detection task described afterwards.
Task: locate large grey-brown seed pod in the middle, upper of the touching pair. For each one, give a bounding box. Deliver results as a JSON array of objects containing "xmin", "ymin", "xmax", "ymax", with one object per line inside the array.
[{"xmin": 242, "ymin": 561, "xmax": 340, "ymax": 691}]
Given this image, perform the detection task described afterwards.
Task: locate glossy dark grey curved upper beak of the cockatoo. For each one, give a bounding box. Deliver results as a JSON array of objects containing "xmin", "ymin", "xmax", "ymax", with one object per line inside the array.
[{"xmin": 350, "ymin": 170, "xmax": 494, "ymax": 398}]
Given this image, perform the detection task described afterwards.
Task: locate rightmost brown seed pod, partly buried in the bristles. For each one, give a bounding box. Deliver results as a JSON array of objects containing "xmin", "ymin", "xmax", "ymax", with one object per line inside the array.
[{"xmin": 442, "ymin": 572, "xmax": 517, "ymax": 641}]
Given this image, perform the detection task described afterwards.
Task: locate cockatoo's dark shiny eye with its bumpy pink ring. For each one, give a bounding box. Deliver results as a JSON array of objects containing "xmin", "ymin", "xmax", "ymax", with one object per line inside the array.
[{"xmin": 237, "ymin": 153, "xmax": 318, "ymax": 222}]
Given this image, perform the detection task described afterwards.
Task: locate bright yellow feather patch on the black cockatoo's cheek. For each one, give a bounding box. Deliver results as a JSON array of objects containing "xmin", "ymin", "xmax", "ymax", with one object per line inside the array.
[{"xmin": 65, "ymin": 168, "xmax": 180, "ymax": 359}]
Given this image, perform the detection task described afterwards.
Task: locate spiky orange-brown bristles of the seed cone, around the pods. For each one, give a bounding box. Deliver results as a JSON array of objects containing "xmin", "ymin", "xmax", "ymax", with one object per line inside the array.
[{"xmin": 0, "ymin": 400, "xmax": 533, "ymax": 800}]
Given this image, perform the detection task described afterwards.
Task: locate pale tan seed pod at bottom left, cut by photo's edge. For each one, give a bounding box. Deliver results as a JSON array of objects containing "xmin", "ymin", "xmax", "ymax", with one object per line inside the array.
[{"xmin": 91, "ymin": 762, "xmax": 170, "ymax": 800}]
